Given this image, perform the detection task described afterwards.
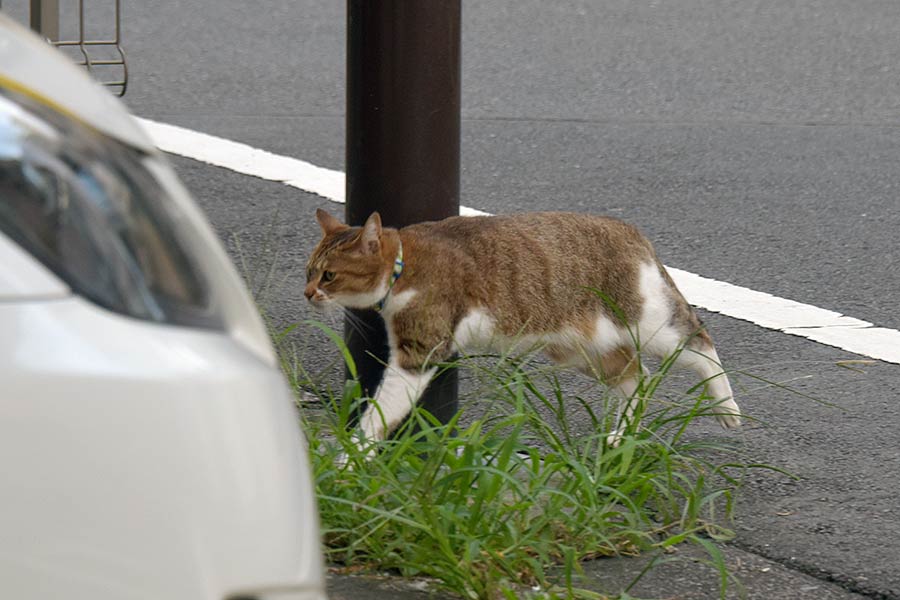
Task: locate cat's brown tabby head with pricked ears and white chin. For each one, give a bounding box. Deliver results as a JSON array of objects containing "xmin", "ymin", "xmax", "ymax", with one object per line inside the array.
[{"xmin": 304, "ymin": 208, "xmax": 391, "ymax": 308}]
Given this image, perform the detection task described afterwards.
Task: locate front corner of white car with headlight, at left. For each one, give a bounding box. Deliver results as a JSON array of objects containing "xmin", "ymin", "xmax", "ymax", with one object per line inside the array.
[{"xmin": 0, "ymin": 15, "xmax": 325, "ymax": 600}]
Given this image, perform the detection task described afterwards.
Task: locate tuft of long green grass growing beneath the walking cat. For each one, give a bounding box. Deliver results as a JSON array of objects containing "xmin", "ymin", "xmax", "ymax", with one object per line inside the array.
[{"xmin": 276, "ymin": 324, "xmax": 764, "ymax": 600}]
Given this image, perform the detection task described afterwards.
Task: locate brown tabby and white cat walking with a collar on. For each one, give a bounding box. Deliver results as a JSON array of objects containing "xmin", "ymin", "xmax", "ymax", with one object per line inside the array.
[{"xmin": 304, "ymin": 209, "xmax": 741, "ymax": 446}]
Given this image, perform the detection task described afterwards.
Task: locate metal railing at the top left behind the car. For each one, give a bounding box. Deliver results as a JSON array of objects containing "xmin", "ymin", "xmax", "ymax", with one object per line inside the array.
[{"xmin": 11, "ymin": 0, "xmax": 128, "ymax": 96}]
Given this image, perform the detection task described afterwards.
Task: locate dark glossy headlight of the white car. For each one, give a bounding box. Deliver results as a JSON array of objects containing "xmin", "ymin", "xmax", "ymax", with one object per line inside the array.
[{"xmin": 0, "ymin": 89, "xmax": 223, "ymax": 328}]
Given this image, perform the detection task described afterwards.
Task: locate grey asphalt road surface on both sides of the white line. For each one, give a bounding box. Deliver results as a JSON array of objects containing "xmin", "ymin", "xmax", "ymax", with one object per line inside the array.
[{"xmin": 75, "ymin": 0, "xmax": 900, "ymax": 598}]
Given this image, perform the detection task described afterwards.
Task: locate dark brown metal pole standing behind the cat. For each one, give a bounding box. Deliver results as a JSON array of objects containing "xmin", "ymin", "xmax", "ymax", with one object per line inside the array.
[{"xmin": 344, "ymin": 0, "xmax": 461, "ymax": 422}]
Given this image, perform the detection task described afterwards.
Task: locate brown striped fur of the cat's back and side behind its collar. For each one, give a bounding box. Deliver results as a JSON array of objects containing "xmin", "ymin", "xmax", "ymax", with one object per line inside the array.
[{"xmin": 402, "ymin": 212, "xmax": 656, "ymax": 336}]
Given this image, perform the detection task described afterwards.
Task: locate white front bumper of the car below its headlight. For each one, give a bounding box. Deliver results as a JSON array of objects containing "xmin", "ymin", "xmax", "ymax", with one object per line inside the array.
[{"xmin": 0, "ymin": 297, "xmax": 322, "ymax": 600}]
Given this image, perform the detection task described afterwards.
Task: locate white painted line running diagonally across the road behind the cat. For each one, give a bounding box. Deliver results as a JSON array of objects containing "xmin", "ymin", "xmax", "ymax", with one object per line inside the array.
[{"xmin": 139, "ymin": 119, "xmax": 900, "ymax": 364}]
